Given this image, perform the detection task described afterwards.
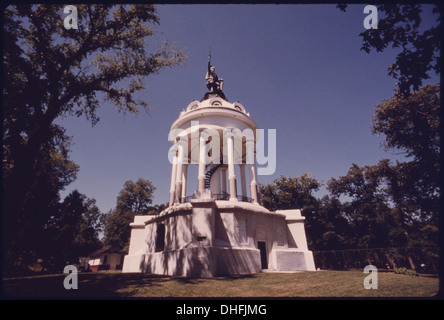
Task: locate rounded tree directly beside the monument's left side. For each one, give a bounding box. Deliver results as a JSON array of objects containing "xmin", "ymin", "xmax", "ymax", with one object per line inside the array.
[{"xmin": 103, "ymin": 178, "xmax": 156, "ymax": 251}]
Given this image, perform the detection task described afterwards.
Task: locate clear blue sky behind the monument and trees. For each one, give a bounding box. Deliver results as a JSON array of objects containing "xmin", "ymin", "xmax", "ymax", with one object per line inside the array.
[{"xmin": 58, "ymin": 4, "xmax": 439, "ymax": 212}]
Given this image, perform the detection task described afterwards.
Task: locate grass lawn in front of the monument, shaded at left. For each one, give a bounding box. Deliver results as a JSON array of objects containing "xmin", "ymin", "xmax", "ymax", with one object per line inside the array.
[{"xmin": 3, "ymin": 271, "xmax": 439, "ymax": 298}]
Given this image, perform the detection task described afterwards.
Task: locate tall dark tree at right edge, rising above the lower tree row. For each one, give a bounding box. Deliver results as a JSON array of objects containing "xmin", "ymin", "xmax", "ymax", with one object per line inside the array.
[{"xmin": 372, "ymin": 84, "xmax": 441, "ymax": 252}]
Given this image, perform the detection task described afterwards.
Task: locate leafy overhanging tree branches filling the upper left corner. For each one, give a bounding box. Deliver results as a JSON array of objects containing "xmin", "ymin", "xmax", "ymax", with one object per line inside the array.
[{"xmin": 4, "ymin": 4, "xmax": 184, "ymax": 123}]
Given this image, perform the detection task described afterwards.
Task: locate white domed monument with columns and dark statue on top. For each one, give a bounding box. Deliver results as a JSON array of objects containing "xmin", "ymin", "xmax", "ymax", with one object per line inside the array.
[{"xmin": 122, "ymin": 58, "xmax": 315, "ymax": 278}]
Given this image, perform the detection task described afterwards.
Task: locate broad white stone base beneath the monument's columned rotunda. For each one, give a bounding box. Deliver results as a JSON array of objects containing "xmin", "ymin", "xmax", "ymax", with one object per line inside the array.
[{"xmin": 122, "ymin": 202, "xmax": 316, "ymax": 278}]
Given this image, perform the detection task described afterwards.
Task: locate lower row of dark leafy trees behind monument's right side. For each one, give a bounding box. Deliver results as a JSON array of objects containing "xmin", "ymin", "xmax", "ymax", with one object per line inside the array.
[{"xmin": 259, "ymin": 145, "xmax": 439, "ymax": 250}]
